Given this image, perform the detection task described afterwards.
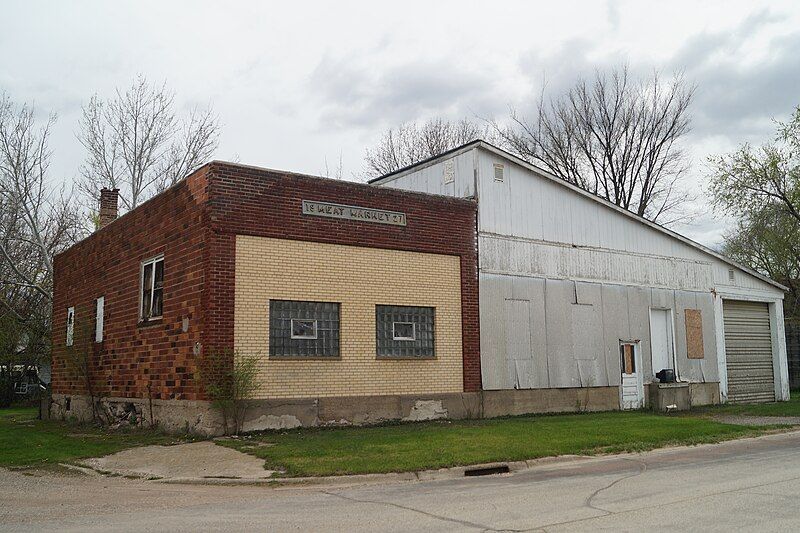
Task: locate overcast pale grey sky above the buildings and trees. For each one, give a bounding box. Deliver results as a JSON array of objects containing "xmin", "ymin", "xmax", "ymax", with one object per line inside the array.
[{"xmin": 0, "ymin": 0, "xmax": 800, "ymax": 245}]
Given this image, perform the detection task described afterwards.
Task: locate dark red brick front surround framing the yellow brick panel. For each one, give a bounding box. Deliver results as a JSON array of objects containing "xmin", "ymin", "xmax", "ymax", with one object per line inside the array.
[{"xmin": 207, "ymin": 163, "xmax": 481, "ymax": 391}]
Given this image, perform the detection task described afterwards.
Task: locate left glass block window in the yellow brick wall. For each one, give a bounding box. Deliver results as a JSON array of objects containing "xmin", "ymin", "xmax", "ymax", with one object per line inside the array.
[{"xmin": 269, "ymin": 300, "xmax": 339, "ymax": 357}]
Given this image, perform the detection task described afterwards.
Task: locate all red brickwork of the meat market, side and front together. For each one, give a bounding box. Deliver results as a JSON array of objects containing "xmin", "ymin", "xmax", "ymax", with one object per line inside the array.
[{"xmin": 53, "ymin": 163, "xmax": 481, "ymax": 399}]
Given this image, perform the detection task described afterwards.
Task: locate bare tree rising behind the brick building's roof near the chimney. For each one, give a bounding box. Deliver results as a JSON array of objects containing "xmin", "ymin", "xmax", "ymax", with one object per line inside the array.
[{"xmin": 79, "ymin": 75, "xmax": 220, "ymax": 210}]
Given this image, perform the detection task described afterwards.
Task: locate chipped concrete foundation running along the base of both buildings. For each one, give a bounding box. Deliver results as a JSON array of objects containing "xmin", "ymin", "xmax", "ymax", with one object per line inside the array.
[{"xmin": 50, "ymin": 383, "xmax": 719, "ymax": 435}]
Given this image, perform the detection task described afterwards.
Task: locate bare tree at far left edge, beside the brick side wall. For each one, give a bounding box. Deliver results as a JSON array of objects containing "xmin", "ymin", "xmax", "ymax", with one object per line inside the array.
[{"xmin": 0, "ymin": 94, "xmax": 82, "ymax": 366}]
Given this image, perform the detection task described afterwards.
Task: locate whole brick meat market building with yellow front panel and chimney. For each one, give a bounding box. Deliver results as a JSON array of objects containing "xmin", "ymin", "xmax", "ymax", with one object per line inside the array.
[{"xmin": 51, "ymin": 162, "xmax": 481, "ymax": 433}]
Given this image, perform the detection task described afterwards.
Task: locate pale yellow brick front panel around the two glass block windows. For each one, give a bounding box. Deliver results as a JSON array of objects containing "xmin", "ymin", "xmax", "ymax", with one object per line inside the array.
[{"xmin": 234, "ymin": 235, "xmax": 463, "ymax": 398}]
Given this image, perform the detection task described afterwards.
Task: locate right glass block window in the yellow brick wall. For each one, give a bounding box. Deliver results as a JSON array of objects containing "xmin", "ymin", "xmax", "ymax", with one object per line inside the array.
[{"xmin": 375, "ymin": 305, "xmax": 434, "ymax": 357}]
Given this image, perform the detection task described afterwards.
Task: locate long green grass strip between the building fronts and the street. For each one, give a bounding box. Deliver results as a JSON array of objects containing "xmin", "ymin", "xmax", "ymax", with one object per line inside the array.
[{"xmin": 217, "ymin": 412, "xmax": 764, "ymax": 476}]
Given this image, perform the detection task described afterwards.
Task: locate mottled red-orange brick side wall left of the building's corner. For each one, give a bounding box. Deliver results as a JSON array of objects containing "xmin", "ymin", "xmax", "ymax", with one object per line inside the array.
[{"xmin": 52, "ymin": 168, "xmax": 207, "ymax": 399}]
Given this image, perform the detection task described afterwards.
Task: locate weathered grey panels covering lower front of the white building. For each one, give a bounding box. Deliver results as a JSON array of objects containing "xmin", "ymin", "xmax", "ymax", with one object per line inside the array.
[{"xmin": 480, "ymin": 273, "xmax": 719, "ymax": 390}]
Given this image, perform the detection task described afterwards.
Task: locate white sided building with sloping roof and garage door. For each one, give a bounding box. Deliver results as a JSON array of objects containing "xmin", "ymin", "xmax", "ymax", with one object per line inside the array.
[{"xmin": 372, "ymin": 141, "xmax": 789, "ymax": 406}]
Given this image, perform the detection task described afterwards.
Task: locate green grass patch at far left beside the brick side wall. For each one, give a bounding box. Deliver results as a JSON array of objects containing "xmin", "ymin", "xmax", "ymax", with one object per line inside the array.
[{"xmin": 0, "ymin": 407, "xmax": 192, "ymax": 467}]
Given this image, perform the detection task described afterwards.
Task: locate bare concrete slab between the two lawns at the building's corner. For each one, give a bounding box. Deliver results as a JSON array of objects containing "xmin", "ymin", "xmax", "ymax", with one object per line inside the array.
[{"xmin": 83, "ymin": 442, "xmax": 273, "ymax": 482}]
